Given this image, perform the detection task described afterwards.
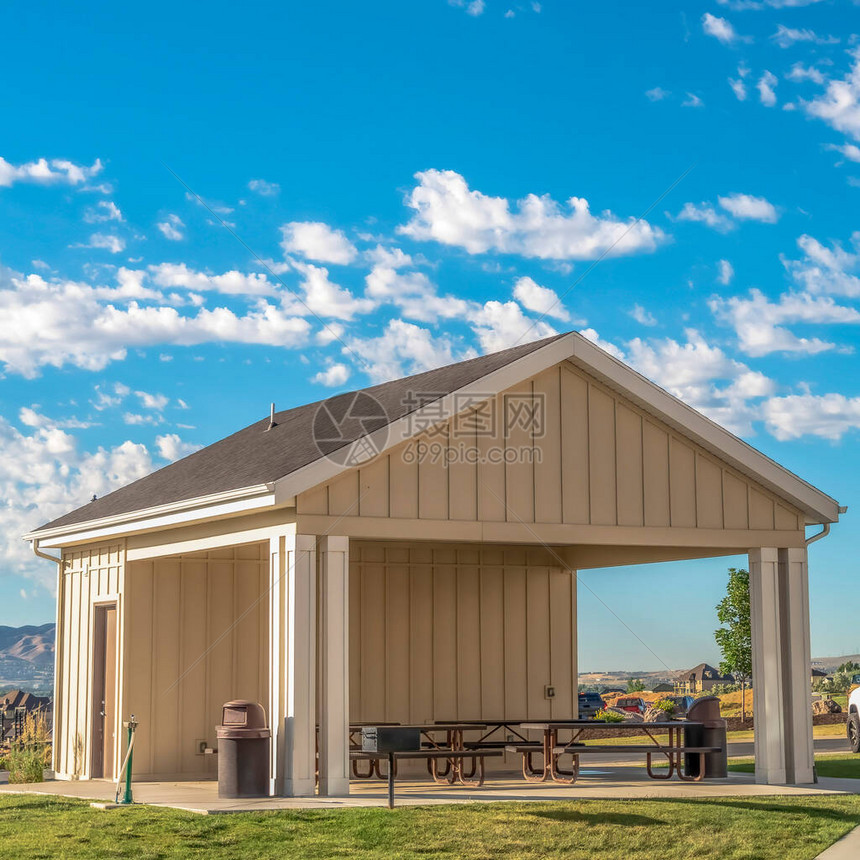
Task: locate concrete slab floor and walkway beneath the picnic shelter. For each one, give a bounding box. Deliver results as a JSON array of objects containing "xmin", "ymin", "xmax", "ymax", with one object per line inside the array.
[{"xmin": 0, "ymin": 767, "xmax": 860, "ymax": 815}]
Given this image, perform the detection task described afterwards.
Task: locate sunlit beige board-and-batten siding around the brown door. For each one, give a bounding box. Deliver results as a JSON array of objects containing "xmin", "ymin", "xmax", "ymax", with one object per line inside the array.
[{"xmin": 53, "ymin": 543, "xmax": 125, "ymax": 779}]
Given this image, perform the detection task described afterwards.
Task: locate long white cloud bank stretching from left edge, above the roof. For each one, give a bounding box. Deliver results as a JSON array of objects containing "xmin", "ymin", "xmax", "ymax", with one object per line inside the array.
[{"xmin": 0, "ymin": 267, "xmax": 310, "ymax": 376}]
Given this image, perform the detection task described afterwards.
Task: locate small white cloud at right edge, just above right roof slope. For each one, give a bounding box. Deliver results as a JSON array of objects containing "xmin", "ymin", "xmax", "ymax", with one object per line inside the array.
[{"xmin": 762, "ymin": 393, "xmax": 860, "ymax": 441}]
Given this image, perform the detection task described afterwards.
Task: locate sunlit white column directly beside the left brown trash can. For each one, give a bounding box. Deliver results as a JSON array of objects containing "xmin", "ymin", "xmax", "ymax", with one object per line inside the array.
[{"xmin": 269, "ymin": 531, "xmax": 316, "ymax": 797}]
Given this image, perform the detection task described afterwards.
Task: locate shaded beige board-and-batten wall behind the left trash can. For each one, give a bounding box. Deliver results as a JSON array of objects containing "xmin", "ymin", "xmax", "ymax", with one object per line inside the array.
[{"xmin": 124, "ymin": 543, "xmax": 269, "ymax": 779}]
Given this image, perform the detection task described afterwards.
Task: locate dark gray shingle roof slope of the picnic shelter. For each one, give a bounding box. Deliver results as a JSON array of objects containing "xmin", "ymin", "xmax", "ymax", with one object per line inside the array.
[{"xmin": 39, "ymin": 334, "xmax": 565, "ymax": 531}]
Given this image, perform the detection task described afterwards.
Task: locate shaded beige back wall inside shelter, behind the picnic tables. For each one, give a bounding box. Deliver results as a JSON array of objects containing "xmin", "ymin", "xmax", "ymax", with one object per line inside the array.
[{"xmin": 349, "ymin": 541, "xmax": 577, "ymax": 723}]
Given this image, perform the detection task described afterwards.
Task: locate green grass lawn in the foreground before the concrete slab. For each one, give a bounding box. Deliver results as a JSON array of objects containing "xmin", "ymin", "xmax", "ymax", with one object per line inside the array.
[{"xmin": 0, "ymin": 795, "xmax": 860, "ymax": 860}]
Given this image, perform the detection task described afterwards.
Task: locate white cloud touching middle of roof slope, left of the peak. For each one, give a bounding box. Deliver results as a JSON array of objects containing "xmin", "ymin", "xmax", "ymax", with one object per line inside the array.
[{"xmin": 348, "ymin": 319, "xmax": 464, "ymax": 383}]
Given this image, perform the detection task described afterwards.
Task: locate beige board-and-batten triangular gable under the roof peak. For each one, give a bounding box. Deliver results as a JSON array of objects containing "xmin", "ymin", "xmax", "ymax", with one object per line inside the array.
[{"xmin": 297, "ymin": 362, "xmax": 803, "ymax": 548}]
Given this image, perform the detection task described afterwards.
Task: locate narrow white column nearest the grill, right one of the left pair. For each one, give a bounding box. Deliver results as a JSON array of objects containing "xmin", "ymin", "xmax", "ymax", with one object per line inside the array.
[{"xmin": 319, "ymin": 536, "xmax": 349, "ymax": 796}]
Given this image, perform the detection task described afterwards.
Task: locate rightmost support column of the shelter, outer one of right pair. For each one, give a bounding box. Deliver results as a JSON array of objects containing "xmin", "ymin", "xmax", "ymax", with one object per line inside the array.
[{"xmin": 779, "ymin": 547, "xmax": 815, "ymax": 784}]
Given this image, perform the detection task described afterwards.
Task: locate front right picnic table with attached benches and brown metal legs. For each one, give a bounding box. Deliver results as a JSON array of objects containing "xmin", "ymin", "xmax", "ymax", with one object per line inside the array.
[{"xmin": 516, "ymin": 720, "xmax": 710, "ymax": 784}]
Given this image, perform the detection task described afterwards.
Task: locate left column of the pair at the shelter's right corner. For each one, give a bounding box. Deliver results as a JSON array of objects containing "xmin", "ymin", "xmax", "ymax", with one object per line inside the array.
[{"xmin": 749, "ymin": 547, "xmax": 786, "ymax": 785}]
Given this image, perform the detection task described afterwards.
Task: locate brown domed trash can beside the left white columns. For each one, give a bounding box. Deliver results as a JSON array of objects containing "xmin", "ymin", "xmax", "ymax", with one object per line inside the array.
[{"xmin": 215, "ymin": 699, "xmax": 272, "ymax": 797}]
